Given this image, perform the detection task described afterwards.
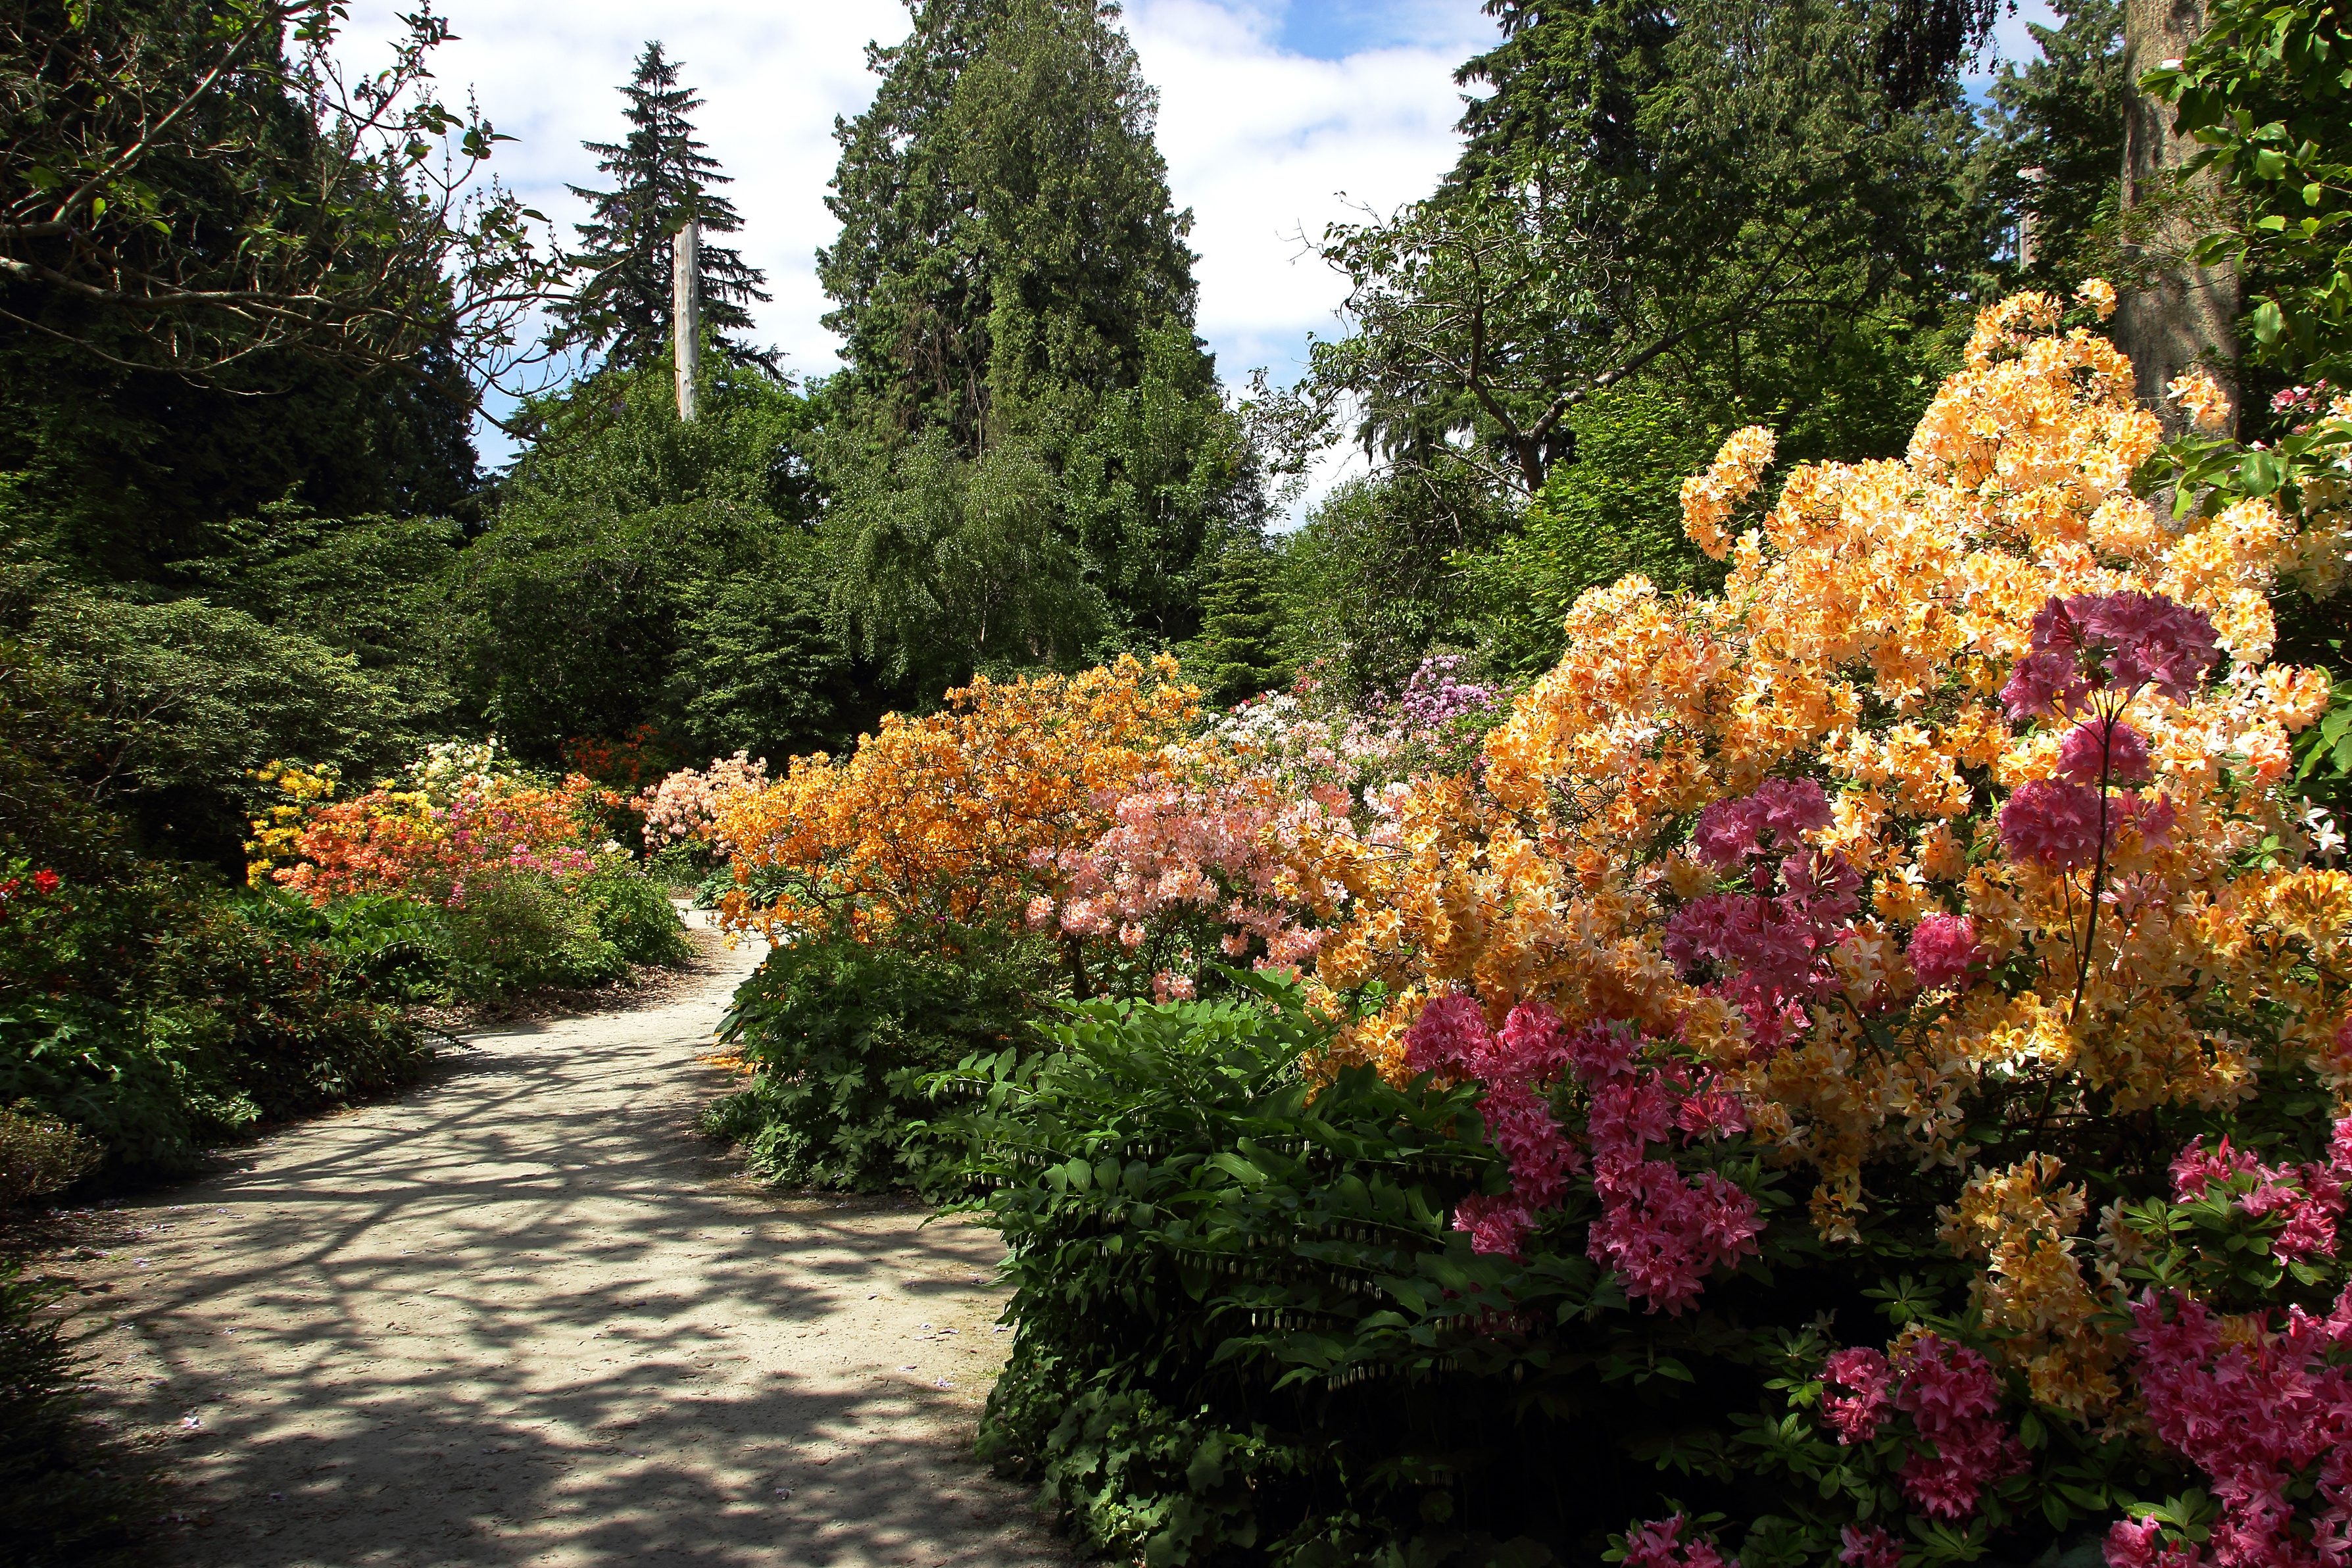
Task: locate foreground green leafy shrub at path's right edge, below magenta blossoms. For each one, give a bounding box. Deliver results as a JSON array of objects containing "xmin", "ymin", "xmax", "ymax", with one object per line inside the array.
[{"xmin": 929, "ymin": 971, "xmax": 1599, "ymax": 1568}]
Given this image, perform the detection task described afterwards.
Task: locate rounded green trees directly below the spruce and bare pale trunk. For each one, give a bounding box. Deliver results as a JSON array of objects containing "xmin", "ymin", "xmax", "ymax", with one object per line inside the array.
[{"xmin": 458, "ymin": 364, "xmax": 846, "ymax": 764}]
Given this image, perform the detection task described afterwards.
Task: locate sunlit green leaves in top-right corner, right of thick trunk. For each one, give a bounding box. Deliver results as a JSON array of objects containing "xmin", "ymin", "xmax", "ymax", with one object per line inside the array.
[{"xmin": 2143, "ymin": 0, "xmax": 2352, "ymax": 385}]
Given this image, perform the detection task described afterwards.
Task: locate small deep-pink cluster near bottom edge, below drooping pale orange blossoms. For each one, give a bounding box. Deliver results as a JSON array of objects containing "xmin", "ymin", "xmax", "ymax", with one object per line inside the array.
[{"xmin": 1821, "ymin": 1333, "xmax": 2025, "ymax": 1523}]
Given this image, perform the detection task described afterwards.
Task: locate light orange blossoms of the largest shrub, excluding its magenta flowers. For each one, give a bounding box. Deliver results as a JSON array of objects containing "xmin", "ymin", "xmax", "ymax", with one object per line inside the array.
[{"xmin": 1298, "ymin": 287, "xmax": 2352, "ymax": 1307}]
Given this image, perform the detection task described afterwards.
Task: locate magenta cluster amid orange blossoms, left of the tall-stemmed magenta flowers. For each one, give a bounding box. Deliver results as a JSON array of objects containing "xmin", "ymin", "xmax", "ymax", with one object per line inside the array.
[{"xmin": 1663, "ymin": 778, "xmax": 1863, "ymax": 1051}]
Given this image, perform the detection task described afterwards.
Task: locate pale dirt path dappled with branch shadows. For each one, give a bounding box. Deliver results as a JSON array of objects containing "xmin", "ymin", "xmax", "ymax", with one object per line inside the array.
[{"xmin": 57, "ymin": 912, "xmax": 1068, "ymax": 1568}]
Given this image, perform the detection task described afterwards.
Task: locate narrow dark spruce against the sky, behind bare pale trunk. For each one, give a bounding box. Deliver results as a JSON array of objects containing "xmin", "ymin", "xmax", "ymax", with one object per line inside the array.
[{"xmin": 555, "ymin": 40, "xmax": 769, "ymax": 367}]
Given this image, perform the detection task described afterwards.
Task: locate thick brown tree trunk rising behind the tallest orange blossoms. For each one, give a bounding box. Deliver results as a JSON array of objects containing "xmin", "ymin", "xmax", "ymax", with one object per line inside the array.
[{"xmin": 2115, "ymin": 0, "xmax": 2244, "ymax": 437}]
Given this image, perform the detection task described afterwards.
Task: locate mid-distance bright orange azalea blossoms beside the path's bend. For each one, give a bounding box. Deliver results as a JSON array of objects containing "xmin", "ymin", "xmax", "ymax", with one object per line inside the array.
[{"xmin": 715, "ymin": 656, "xmax": 1200, "ymax": 943}]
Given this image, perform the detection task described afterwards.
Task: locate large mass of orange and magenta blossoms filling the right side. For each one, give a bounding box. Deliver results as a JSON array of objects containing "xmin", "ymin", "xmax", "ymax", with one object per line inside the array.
[{"xmin": 1213, "ymin": 294, "xmax": 2352, "ymax": 1565}]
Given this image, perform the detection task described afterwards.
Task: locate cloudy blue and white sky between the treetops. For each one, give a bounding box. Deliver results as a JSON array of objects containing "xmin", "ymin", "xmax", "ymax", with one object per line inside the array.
[{"xmin": 348, "ymin": 0, "xmax": 2049, "ymax": 502}]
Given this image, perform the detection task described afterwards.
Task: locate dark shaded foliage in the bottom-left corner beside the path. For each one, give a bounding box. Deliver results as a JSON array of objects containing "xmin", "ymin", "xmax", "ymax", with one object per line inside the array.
[{"xmin": 0, "ymin": 1258, "xmax": 155, "ymax": 1568}]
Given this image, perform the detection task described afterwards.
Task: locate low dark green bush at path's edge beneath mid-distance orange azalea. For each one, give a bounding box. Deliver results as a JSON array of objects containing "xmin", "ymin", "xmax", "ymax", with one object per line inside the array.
[{"xmin": 703, "ymin": 941, "xmax": 1033, "ymax": 1192}]
